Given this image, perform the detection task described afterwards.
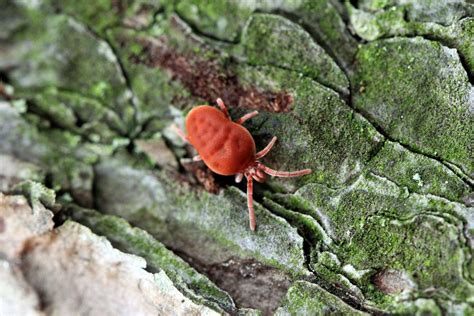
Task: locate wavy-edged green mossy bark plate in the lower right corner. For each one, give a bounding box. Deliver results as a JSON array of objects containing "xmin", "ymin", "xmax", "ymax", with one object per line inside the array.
[{"xmin": 341, "ymin": 212, "xmax": 473, "ymax": 299}]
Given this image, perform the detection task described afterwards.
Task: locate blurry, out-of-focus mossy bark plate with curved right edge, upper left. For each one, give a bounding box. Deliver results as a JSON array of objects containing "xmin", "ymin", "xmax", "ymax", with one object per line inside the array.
[{"xmin": 0, "ymin": 15, "xmax": 134, "ymax": 134}]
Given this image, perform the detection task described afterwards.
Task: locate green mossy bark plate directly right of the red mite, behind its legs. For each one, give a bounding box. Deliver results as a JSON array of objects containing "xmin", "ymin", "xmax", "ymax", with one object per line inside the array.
[{"xmin": 236, "ymin": 66, "xmax": 383, "ymax": 187}]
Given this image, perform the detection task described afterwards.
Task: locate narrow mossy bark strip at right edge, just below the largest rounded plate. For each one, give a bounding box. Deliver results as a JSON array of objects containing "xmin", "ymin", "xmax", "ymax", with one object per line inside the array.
[{"xmin": 367, "ymin": 141, "xmax": 471, "ymax": 202}]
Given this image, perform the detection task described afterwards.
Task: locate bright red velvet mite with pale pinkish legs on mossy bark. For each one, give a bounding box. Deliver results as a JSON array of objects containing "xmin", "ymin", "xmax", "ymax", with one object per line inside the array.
[{"xmin": 175, "ymin": 99, "xmax": 311, "ymax": 230}]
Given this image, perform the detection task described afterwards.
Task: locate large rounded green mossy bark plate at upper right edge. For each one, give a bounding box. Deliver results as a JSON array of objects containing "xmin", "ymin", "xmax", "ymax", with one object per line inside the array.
[{"xmin": 351, "ymin": 38, "xmax": 474, "ymax": 174}]
